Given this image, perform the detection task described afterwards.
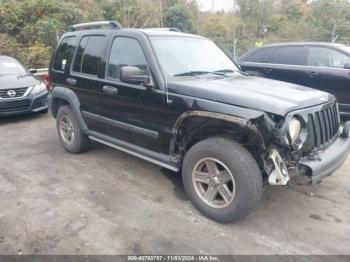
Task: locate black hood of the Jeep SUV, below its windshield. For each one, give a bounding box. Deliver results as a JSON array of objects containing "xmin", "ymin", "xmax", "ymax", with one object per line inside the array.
[{"xmin": 168, "ymin": 75, "xmax": 334, "ymax": 116}]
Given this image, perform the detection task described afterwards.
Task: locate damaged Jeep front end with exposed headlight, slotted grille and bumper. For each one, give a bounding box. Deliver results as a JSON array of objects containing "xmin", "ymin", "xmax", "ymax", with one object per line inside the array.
[{"xmin": 265, "ymin": 101, "xmax": 350, "ymax": 185}]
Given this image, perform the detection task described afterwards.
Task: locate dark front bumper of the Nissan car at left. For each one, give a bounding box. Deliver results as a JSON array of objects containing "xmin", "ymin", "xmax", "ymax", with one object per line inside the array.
[{"xmin": 0, "ymin": 92, "xmax": 48, "ymax": 116}]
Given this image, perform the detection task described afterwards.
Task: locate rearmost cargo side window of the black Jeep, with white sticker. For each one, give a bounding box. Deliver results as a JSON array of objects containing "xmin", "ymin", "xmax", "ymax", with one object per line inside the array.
[{"xmin": 53, "ymin": 36, "xmax": 76, "ymax": 72}]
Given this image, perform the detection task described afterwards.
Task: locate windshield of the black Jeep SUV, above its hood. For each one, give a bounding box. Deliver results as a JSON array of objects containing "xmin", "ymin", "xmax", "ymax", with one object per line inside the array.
[{"xmin": 151, "ymin": 37, "xmax": 238, "ymax": 76}]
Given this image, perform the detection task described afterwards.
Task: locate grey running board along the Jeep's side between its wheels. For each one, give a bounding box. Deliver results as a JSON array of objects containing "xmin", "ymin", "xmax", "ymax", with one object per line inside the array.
[{"xmin": 87, "ymin": 131, "xmax": 180, "ymax": 172}]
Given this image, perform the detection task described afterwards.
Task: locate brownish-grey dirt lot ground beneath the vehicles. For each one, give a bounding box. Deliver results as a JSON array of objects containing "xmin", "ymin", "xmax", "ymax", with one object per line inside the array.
[{"xmin": 0, "ymin": 115, "xmax": 350, "ymax": 254}]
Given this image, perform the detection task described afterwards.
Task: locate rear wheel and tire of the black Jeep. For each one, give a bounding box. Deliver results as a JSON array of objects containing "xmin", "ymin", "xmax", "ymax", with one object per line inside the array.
[{"xmin": 56, "ymin": 105, "xmax": 90, "ymax": 154}]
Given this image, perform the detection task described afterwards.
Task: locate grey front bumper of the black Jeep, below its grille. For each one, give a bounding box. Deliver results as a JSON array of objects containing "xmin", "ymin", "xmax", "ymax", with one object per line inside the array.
[{"xmin": 299, "ymin": 126, "xmax": 350, "ymax": 183}]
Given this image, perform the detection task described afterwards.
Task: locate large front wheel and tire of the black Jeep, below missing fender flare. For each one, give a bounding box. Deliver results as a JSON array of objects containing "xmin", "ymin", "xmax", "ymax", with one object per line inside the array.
[{"xmin": 182, "ymin": 137, "xmax": 263, "ymax": 223}]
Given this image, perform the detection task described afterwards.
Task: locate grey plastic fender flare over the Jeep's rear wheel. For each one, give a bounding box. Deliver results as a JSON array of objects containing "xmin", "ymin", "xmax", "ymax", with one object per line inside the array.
[{"xmin": 49, "ymin": 86, "xmax": 88, "ymax": 131}]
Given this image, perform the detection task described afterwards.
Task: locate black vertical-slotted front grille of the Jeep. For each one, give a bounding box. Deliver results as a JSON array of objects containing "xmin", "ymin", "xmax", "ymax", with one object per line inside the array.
[{"xmin": 308, "ymin": 102, "xmax": 340, "ymax": 149}]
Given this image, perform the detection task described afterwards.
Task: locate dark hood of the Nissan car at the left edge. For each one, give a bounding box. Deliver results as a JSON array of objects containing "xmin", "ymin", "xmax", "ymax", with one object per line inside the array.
[{"xmin": 0, "ymin": 75, "xmax": 40, "ymax": 90}]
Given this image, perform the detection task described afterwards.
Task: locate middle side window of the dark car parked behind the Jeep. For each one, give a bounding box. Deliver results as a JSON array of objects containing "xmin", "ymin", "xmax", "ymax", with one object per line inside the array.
[{"xmin": 269, "ymin": 46, "xmax": 304, "ymax": 65}]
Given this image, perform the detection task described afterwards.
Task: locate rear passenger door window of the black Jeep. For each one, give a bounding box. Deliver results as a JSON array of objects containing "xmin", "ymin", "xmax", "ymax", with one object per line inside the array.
[{"xmin": 73, "ymin": 36, "xmax": 105, "ymax": 76}]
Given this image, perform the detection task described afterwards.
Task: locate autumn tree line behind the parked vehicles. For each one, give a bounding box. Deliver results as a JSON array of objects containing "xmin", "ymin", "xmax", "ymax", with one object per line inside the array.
[{"xmin": 0, "ymin": 0, "xmax": 350, "ymax": 67}]
